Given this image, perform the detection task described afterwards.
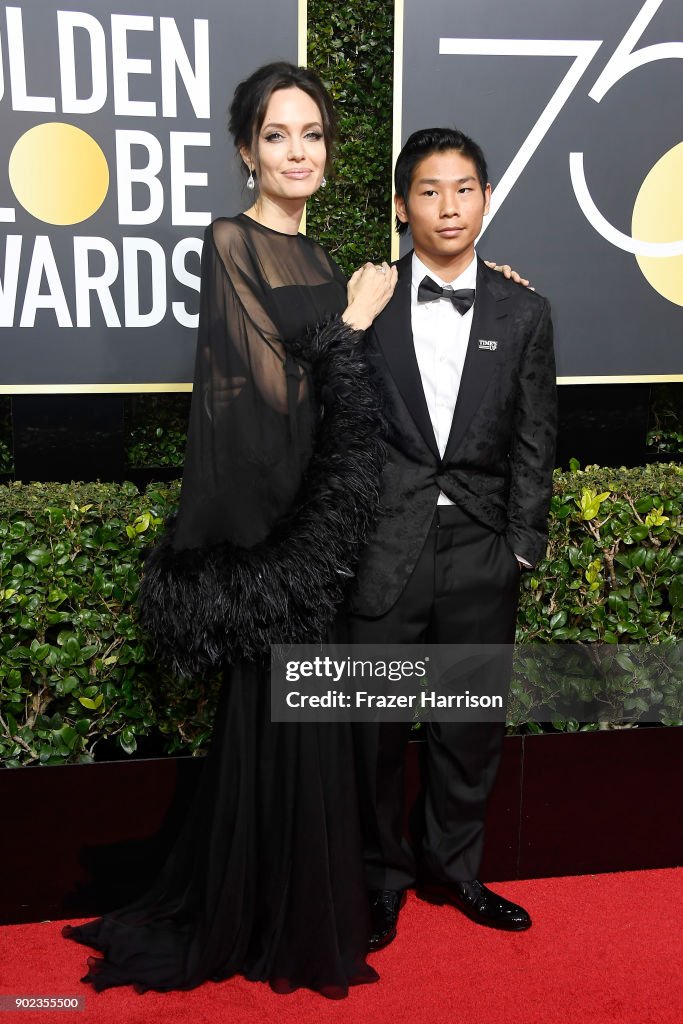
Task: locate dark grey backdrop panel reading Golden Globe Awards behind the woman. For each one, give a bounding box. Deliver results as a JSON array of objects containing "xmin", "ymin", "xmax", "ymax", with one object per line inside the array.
[{"xmin": 0, "ymin": 0, "xmax": 305, "ymax": 393}]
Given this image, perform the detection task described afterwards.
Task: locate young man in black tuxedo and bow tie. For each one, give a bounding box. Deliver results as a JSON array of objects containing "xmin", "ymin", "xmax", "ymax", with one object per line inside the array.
[{"xmin": 350, "ymin": 129, "xmax": 556, "ymax": 949}]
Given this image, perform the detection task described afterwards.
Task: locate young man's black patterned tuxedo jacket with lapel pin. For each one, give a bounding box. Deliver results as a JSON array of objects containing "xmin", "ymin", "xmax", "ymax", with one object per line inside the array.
[{"xmin": 351, "ymin": 252, "xmax": 556, "ymax": 615}]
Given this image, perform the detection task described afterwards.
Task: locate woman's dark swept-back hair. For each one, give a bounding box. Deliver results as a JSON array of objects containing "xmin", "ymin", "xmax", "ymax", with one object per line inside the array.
[{"xmin": 228, "ymin": 60, "xmax": 337, "ymax": 177}]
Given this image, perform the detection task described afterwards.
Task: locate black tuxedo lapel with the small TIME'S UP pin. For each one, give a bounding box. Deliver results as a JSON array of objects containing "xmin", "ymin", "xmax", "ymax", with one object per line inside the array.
[{"xmin": 443, "ymin": 258, "xmax": 508, "ymax": 460}]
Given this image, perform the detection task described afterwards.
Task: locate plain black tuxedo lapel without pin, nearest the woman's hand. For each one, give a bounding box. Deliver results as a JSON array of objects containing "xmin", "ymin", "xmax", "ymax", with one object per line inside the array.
[{"xmin": 374, "ymin": 252, "xmax": 440, "ymax": 459}]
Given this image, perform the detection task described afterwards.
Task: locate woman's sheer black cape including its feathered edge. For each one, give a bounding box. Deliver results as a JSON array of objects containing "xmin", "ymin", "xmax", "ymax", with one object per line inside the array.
[{"xmin": 140, "ymin": 217, "xmax": 383, "ymax": 675}]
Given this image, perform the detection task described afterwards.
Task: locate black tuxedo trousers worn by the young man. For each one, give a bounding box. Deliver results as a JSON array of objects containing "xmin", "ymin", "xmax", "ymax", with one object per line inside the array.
[{"xmin": 348, "ymin": 505, "xmax": 519, "ymax": 889}]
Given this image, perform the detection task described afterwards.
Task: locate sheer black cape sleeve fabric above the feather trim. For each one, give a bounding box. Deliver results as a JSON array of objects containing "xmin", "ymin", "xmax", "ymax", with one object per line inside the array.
[{"xmin": 173, "ymin": 221, "xmax": 313, "ymax": 550}]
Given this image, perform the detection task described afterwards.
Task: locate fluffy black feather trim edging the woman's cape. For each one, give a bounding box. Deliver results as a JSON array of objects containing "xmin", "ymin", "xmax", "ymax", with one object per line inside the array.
[{"xmin": 140, "ymin": 316, "xmax": 385, "ymax": 676}]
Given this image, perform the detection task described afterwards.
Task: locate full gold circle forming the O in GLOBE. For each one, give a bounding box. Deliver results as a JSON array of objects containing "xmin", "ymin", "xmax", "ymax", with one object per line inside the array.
[{"xmin": 9, "ymin": 121, "xmax": 110, "ymax": 224}]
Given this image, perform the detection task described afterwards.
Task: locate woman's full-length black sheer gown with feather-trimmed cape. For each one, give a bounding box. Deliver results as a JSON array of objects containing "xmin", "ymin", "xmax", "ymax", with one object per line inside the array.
[{"xmin": 63, "ymin": 215, "xmax": 383, "ymax": 997}]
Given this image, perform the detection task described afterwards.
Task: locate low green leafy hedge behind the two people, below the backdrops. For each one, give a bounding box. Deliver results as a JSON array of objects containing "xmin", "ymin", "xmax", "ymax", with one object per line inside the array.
[{"xmin": 0, "ymin": 465, "xmax": 683, "ymax": 766}]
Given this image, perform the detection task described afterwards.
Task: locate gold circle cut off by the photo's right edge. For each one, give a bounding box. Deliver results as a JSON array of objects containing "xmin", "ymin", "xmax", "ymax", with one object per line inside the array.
[{"xmin": 631, "ymin": 142, "xmax": 683, "ymax": 306}]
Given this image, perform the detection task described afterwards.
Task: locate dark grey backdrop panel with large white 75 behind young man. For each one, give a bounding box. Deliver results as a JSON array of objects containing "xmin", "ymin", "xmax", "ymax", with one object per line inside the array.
[{"xmin": 394, "ymin": 0, "xmax": 683, "ymax": 383}]
